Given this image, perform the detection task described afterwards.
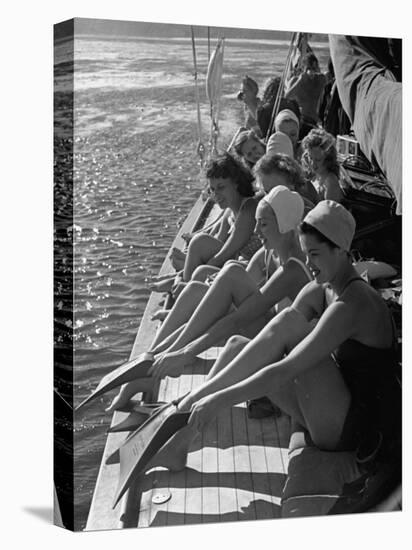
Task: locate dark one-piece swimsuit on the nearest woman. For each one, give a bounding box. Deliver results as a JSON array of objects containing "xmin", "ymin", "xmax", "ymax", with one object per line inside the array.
[{"xmin": 333, "ymin": 277, "xmax": 401, "ymax": 461}]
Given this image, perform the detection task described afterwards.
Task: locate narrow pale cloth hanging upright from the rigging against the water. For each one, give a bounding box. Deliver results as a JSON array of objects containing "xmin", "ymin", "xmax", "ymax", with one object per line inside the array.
[{"xmin": 206, "ymin": 38, "xmax": 225, "ymax": 155}]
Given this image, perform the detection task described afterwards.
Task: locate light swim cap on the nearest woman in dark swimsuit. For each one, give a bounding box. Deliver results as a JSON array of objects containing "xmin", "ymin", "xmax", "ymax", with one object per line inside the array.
[{"xmin": 303, "ymin": 200, "xmax": 356, "ymax": 252}]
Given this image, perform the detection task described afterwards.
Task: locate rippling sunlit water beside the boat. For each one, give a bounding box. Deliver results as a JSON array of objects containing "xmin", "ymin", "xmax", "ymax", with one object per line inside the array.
[{"xmin": 55, "ymin": 30, "xmax": 327, "ymax": 529}]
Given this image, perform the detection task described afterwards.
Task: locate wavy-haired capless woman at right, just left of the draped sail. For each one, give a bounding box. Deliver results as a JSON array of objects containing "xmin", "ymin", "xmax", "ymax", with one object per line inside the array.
[{"xmin": 301, "ymin": 128, "xmax": 343, "ymax": 202}]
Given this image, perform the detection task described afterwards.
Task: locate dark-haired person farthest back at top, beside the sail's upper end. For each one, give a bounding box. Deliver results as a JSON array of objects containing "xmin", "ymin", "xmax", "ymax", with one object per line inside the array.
[{"xmin": 285, "ymin": 53, "xmax": 326, "ymax": 139}]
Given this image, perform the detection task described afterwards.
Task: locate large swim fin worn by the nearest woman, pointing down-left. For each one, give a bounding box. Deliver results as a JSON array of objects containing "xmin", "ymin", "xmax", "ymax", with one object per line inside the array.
[{"xmin": 113, "ymin": 397, "xmax": 190, "ymax": 508}]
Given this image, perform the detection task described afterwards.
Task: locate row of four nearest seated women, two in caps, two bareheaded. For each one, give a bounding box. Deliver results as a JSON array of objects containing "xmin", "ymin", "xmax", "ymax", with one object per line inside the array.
[{"xmin": 106, "ymin": 154, "xmax": 400, "ymax": 469}]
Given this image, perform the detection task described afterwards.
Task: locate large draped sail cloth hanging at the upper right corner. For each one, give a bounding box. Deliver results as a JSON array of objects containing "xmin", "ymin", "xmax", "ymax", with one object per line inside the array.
[{"xmin": 329, "ymin": 35, "xmax": 402, "ymax": 214}]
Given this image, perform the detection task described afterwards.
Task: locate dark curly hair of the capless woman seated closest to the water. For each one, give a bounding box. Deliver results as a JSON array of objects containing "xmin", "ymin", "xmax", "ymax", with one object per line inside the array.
[{"xmin": 206, "ymin": 153, "xmax": 255, "ymax": 197}]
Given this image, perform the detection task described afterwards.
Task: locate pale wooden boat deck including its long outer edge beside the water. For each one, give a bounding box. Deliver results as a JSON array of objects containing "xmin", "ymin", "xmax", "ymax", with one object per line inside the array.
[{"xmin": 85, "ymin": 199, "xmax": 289, "ymax": 530}]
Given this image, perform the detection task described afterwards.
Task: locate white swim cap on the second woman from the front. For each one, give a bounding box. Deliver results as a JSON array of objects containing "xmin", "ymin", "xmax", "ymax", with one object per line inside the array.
[{"xmin": 262, "ymin": 185, "xmax": 304, "ymax": 233}]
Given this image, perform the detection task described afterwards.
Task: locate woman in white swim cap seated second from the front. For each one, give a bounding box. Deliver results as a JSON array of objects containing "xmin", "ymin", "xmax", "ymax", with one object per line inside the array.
[{"xmin": 106, "ymin": 186, "xmax": 311, "ymax": 412}]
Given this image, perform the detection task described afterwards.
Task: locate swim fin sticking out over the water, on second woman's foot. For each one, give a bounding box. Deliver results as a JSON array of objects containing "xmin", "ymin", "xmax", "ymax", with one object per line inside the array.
[{"xmin": 74, "ymin": 352, "xmax": 154, "ymax": 411}]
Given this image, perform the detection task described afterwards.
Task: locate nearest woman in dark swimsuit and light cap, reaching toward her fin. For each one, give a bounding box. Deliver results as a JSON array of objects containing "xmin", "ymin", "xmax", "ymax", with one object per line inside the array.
[{"xmin": 150, "ymin": 201, "xmax": 400, "ymax": 469}]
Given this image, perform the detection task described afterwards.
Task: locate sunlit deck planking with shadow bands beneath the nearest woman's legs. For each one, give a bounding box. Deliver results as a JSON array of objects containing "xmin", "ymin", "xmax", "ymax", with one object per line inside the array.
[{"xmin": 132, "ymin": 349, "xmax": 288, "ymax": 527}]
